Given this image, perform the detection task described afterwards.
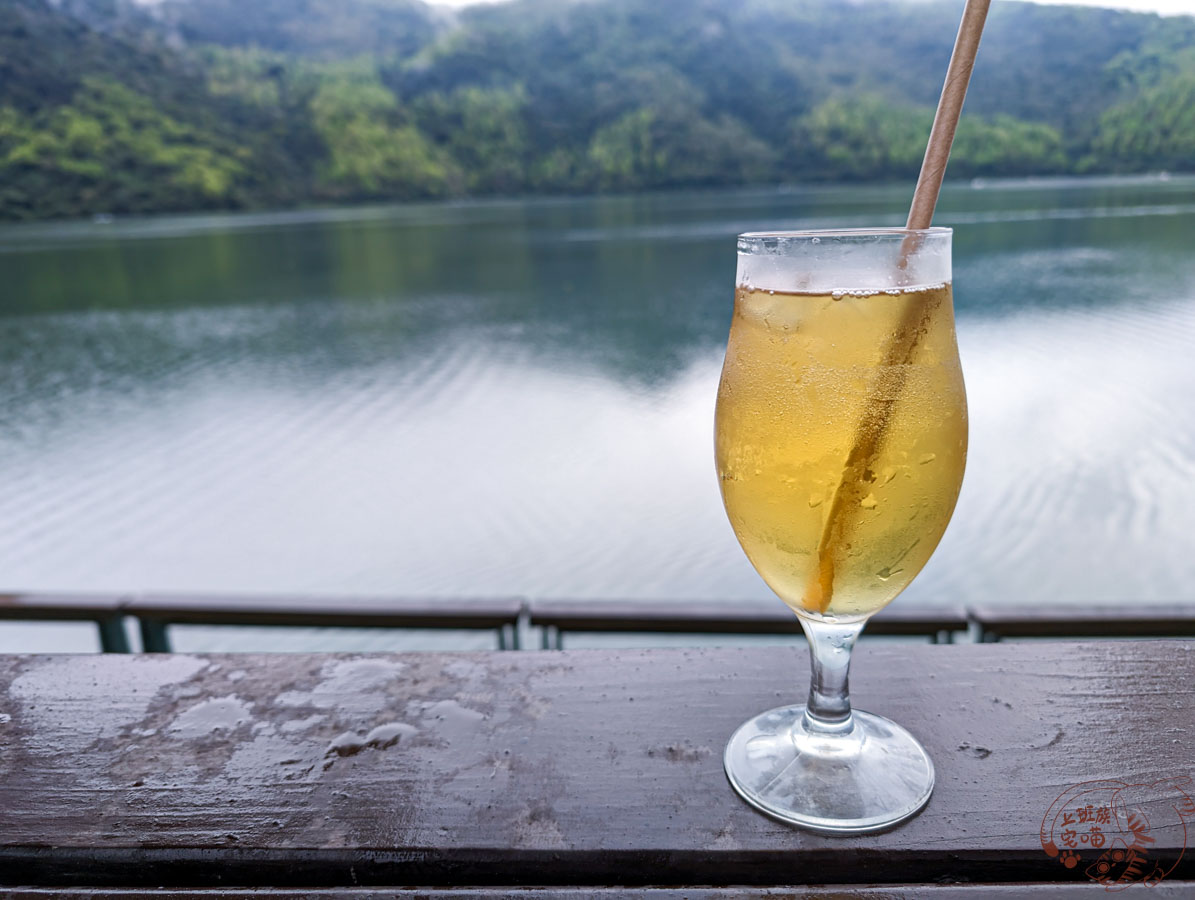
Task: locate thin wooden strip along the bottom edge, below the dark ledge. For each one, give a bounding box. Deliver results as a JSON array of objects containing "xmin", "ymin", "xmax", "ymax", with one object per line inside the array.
[{"xmin": 7, "ymin": 880, "xmax": 1195, "ymax": 900}]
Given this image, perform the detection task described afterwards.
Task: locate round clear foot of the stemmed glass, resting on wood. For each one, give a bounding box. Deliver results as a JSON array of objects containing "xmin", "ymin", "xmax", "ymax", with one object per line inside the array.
[{"xmin": 724, "ymin": 706, "xmax": 933, "ymax": 834}]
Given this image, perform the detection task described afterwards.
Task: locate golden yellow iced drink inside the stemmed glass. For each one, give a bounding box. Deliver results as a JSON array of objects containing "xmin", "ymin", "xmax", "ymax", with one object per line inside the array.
[{"xmin": 715, "ymin": 284, "xmax": 967, "ymax": 618}]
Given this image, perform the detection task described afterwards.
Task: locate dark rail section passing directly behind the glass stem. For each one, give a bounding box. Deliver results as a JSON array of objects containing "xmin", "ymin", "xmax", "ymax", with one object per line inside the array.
[{"xmin": 528, "ymin": 600, "xmax": 968, "ymax": 635}]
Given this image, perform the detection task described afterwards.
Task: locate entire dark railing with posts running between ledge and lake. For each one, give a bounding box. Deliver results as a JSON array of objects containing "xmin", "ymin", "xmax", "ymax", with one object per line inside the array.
[{"xmin": 7, "ymin": 593, "xmax": 1195, "ymax": 653}]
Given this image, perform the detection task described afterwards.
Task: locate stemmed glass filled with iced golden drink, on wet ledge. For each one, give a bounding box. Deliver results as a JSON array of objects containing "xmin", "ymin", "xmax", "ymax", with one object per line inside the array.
[{"xmin": 715, "ymin": 228, "xmax": 967, "ymax": 834}]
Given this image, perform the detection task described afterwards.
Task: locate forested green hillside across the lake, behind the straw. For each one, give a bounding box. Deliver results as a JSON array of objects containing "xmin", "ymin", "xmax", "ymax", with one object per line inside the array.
[{"xmin": 0, "ymin": 0, "xmax": 1195, "ymax": 219}]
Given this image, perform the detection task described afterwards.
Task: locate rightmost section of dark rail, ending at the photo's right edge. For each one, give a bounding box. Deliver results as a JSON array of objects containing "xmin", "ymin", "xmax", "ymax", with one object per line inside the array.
[{"xmin": 970, "ymin": 604, "xmax": 1195, "ymax": 637}]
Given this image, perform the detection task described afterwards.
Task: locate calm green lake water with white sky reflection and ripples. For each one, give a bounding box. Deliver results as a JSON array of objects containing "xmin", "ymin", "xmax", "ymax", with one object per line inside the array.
[{"xmin": 0, "ymin": 177, "xmax": 1195, "ymax": 649}]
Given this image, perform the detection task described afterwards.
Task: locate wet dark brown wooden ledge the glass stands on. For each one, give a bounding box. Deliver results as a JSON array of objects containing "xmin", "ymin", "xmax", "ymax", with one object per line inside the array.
[{"xmin": 0, "ymin": 641, "xmax": 1195, "ymax": 895}]
